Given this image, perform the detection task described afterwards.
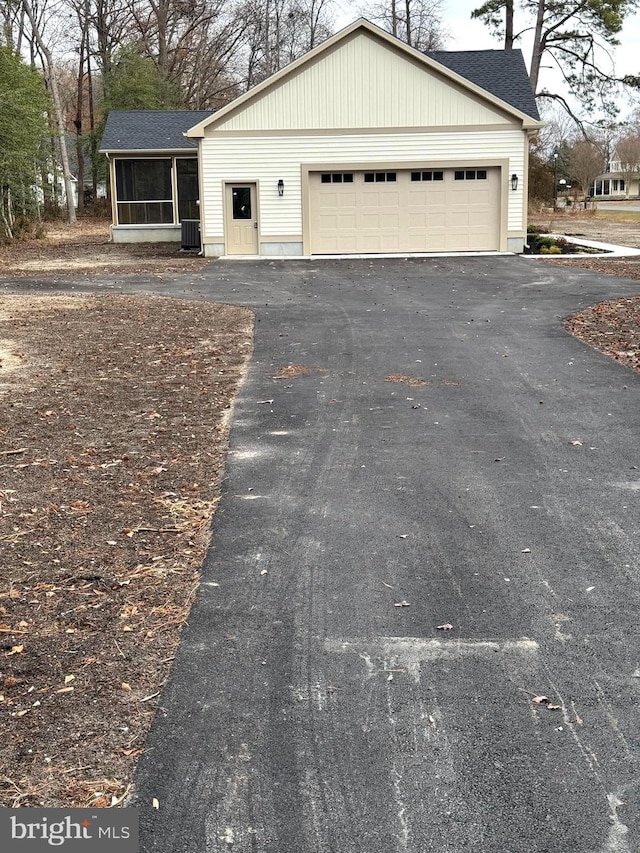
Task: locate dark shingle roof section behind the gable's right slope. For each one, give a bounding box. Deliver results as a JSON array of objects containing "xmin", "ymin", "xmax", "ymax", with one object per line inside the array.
[{"xmin": 427, "ymin": 49, "xmax": 540, "ymax": 120}]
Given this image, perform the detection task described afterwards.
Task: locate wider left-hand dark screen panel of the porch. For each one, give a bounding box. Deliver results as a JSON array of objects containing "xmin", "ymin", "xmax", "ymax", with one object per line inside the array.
[{"xmin": 116, "ymin": 159, "xmax": 173, "ymax": 225}]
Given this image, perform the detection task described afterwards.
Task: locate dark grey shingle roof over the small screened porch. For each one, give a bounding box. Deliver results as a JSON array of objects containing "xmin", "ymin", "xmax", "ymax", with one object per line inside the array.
[{"xmin": 100, "ymin": 110, "xmax": 213, "ymax": 151}]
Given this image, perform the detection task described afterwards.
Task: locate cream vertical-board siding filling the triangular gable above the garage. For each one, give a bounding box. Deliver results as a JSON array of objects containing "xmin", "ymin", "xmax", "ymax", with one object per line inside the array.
[{"xmin": 205, "ymin": 33, "xmax": 513, "ymax": 136}]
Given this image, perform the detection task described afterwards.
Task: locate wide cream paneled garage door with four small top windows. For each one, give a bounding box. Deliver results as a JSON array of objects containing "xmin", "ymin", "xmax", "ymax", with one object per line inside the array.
[{"xmin": 309, "ymin": 167, "xmax": 500, "ymax": 254}]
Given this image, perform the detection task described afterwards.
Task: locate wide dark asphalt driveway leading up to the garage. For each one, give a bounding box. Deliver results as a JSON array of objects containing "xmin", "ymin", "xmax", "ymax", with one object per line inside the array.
[{"xmin": 2, "ymin": 257, "xmax": 640, "ymax": 853}]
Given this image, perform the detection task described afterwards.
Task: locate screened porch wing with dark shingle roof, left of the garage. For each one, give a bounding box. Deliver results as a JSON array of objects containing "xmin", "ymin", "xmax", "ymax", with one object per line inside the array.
[{"xmin": 100, "ymin": 110, "xmax": 212, "ymax": 243}]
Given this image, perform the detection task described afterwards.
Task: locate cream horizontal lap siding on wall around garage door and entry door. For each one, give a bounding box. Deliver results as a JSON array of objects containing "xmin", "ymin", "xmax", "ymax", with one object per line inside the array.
[{"xmin": 201, "ymin": 127, "xmax": 526, "ymax": 243}]
